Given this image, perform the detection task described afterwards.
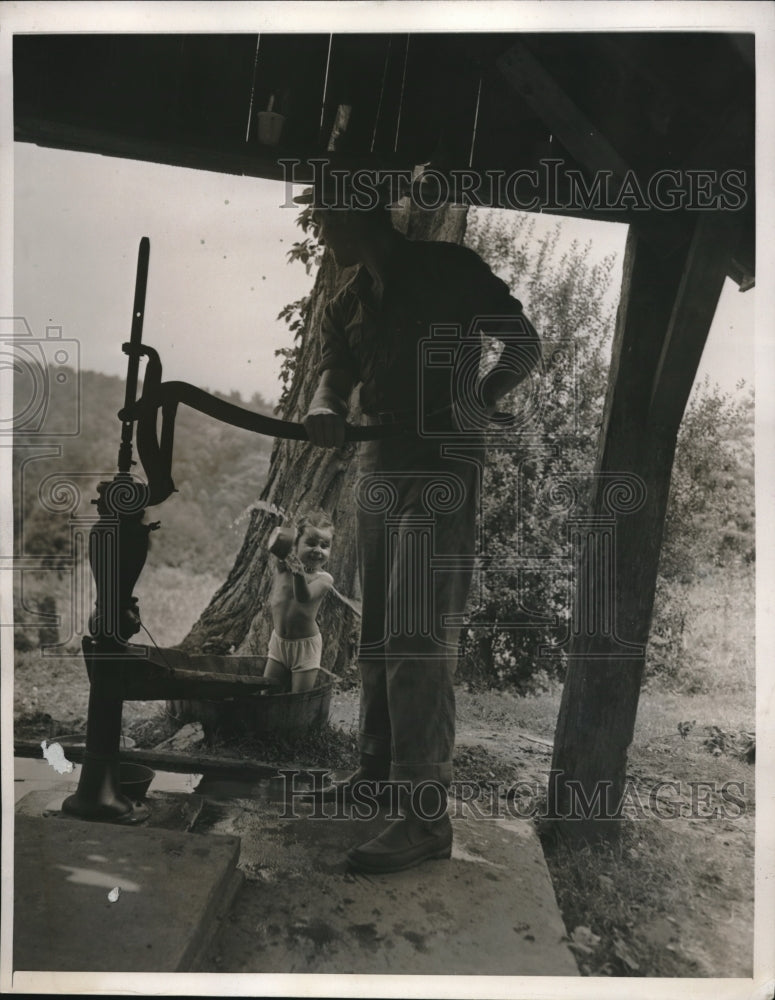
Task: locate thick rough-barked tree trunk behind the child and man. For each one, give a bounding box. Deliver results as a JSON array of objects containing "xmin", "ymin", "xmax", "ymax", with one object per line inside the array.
[{"xmin": 171, "ymin": 205, "xmax": 466, "ymax": 715}]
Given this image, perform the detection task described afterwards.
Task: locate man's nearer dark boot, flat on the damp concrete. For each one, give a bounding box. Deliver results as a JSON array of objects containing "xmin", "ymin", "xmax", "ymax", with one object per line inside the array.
[{"xmin": 347, "ymin": 784, "xmax": 452, "ymax": 875}]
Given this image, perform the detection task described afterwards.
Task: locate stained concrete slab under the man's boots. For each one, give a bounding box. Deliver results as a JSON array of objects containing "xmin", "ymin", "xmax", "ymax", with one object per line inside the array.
[{"xmin": 199, "ymin": 785, "xmax": 578, "ymax": 976}]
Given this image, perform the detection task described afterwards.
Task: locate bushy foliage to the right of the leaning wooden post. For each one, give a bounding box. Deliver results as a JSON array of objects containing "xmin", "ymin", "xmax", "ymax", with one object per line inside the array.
[{"xmin": 645, "ymin": 378, "xmax": 756, "ymax": 693}]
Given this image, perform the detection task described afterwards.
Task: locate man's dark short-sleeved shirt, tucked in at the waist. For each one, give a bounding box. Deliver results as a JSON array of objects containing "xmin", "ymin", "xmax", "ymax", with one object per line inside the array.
[{"xmin": 319, "ymin": 237, "xmax": 521, "ymax": 415}]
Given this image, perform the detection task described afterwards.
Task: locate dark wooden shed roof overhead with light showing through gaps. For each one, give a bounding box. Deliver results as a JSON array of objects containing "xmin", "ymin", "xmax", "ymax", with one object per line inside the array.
[{"xmin": 13, "ymin": 32, "xmax": 755, "ymax": 280}]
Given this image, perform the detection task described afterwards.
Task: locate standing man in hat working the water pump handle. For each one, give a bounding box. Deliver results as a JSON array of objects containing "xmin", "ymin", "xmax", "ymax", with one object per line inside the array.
[{"xmin": 296, "ymin": 176, "xmax": 540, "ymax": 872}]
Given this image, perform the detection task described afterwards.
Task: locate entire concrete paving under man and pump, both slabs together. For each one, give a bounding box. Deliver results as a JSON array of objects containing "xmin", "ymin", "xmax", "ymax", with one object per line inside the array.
[{"xmin": 15, "ymin": 762, "xmax": 578, "ymax": 976}]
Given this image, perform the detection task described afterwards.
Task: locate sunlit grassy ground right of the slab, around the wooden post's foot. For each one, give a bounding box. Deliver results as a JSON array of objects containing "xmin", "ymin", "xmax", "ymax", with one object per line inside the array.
[{"xmin": 536, "ymin": 572, "xmax": 755, "ymax": 977}]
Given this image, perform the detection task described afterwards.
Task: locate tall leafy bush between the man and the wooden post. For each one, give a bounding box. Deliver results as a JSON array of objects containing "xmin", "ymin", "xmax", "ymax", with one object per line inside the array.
[{"xmin": 461, "ymin": 211, "xmax": 614, "ymax": 691}]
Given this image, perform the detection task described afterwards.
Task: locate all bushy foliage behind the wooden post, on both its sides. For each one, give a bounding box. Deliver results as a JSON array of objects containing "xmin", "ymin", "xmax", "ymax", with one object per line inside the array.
[{"xmin": 460, "ymin": 211, "xmax": 754, "ymax": 692}]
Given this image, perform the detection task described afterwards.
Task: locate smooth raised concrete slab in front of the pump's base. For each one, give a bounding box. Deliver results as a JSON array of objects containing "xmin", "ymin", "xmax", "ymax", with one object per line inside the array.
[{"xmin": 14, "ymin": 809, "xmax": 240, "ymax": 972}]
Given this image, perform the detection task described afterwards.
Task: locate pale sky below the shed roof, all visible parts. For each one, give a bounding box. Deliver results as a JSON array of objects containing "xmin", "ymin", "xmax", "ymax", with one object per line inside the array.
[{"xmin": 14, "ymin": 143, "xmax": 756, "ymax": 401}]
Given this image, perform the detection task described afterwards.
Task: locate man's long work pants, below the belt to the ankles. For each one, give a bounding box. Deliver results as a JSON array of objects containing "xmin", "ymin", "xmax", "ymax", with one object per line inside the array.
[{"xmin": 357, "ymin": 439, "xmax": 482, "ymax": 785}]
